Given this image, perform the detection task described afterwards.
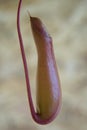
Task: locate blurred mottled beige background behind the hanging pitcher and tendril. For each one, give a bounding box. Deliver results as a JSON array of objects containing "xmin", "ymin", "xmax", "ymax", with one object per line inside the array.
[{"xmin": 0, "ymin": 0, "xmax": 87, "ymax": 130}]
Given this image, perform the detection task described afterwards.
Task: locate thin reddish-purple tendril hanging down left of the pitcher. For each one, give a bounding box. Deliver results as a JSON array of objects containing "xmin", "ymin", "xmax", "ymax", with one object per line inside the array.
[{"xmin": 17, "ymin": 0, "xmax": 36, "ymax": 122}]
